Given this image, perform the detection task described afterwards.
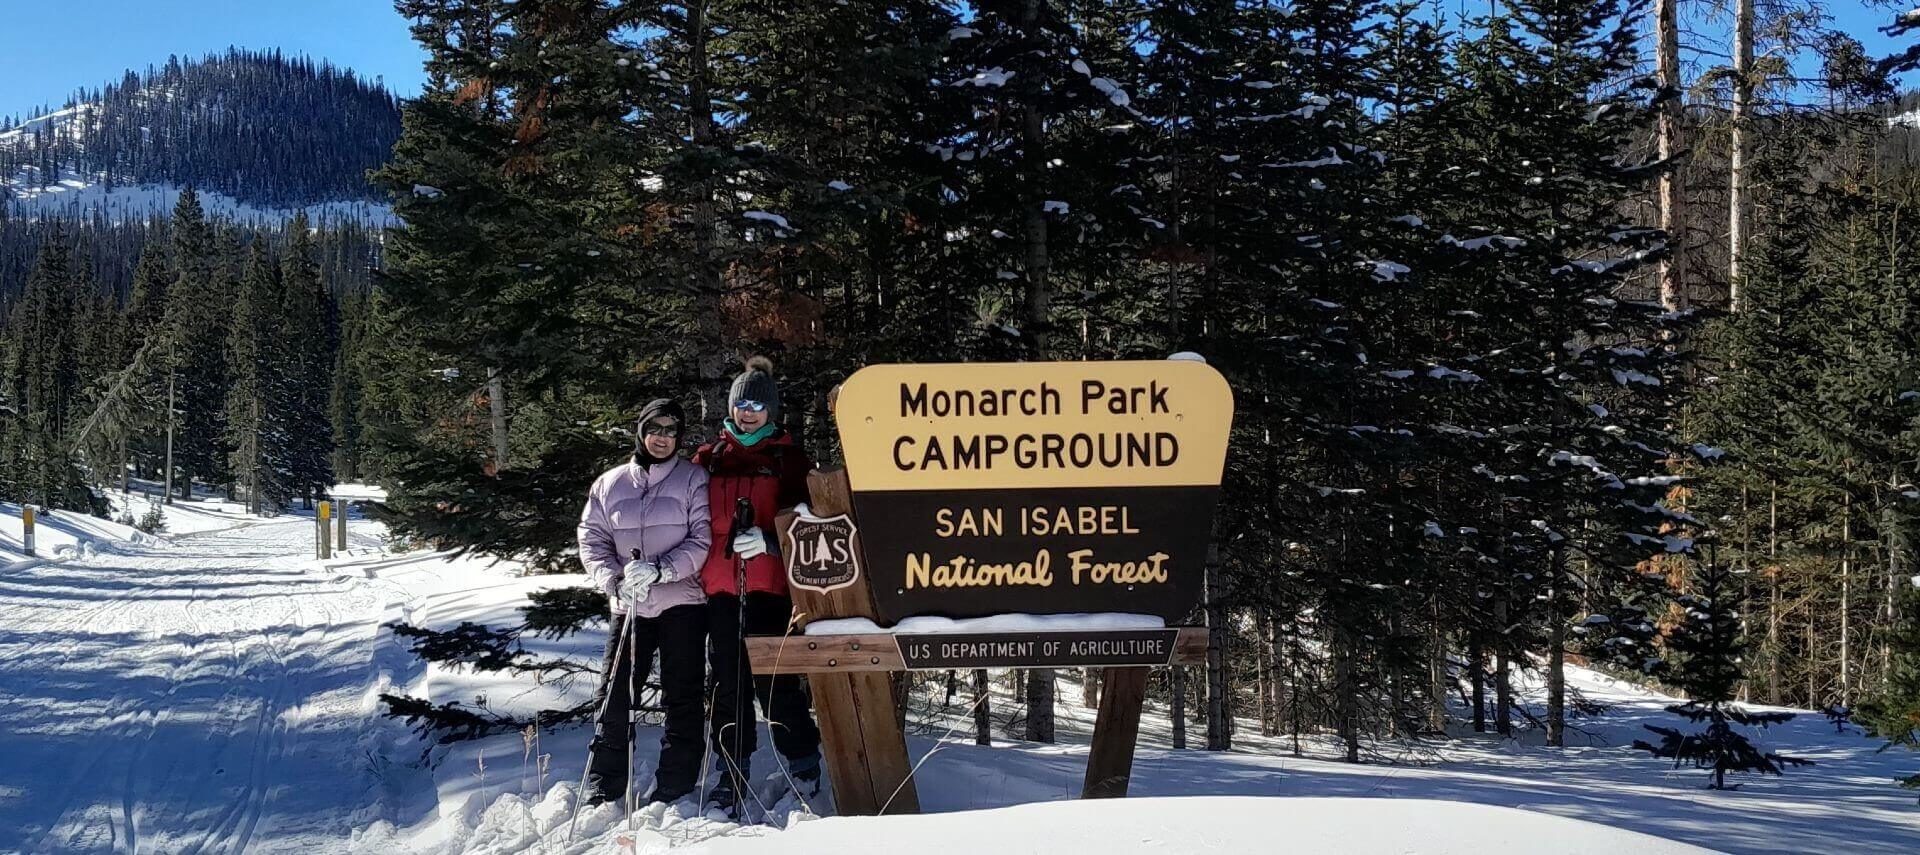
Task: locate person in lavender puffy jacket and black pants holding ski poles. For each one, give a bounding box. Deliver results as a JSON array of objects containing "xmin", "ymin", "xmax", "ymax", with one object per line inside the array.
[{"xmin": 580, "ymin": 398, "xmax": 712, "ymax": 803}]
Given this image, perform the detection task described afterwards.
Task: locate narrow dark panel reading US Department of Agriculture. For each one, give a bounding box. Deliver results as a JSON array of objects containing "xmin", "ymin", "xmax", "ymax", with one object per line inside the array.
[{"xmin": 895, "ymin": 628, "xmax": 1181, "ymax": 671}]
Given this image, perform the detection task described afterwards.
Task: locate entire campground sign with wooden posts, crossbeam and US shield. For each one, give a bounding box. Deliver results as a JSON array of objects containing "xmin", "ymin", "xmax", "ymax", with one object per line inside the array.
[{"xmin": 747, "ymin": 361, "xmax": 1233, "ymax": 815}]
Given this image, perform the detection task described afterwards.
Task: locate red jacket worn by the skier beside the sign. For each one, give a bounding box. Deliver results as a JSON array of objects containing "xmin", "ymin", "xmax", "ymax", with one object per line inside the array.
[{"xmin": 693, "ymin": 430, "xmax": 814, "ymax": 596}]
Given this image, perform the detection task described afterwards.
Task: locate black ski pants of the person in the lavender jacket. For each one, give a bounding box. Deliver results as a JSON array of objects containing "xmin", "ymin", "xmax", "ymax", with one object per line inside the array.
[{"xmin": 588, "ymin": 603, "xmax": 707, "ymax": 801}]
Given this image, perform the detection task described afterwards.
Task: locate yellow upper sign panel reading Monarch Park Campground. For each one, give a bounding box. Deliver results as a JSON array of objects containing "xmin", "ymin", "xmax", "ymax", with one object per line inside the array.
[{"xmin": 837, "ymin": 359, "xmax": 1233, "ymax": 492}]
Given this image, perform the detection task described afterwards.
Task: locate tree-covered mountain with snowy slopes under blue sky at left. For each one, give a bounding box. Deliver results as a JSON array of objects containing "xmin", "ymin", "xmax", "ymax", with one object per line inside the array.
[{"xmin": 0, "ymin": 50, "xmax": 399, "ymax": 225}]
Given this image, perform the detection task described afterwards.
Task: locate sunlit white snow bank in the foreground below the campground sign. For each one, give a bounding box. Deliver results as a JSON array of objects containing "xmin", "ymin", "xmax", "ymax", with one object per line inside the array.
[{"xmin": 420, "ymin": 784, "xmax": 1711, "ymax": 855}]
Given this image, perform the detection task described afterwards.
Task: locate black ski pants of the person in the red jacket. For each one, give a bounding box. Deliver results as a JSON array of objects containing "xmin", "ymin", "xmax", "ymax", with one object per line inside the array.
[{"xmin": 707, "ymin": 592, "xmax": 820, "ymax": 769}]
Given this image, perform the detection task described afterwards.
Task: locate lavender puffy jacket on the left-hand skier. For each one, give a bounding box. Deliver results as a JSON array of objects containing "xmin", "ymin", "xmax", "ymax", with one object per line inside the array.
[{"xmin": 580, "ymin": 457, "xmax": 712, "ymax": 617}]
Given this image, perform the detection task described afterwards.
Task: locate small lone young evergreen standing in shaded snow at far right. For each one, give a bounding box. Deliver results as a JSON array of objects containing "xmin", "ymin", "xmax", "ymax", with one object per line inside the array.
[{"xmin": 1634, "ymin": 557, "xmax": 1812, "ymax": 790}]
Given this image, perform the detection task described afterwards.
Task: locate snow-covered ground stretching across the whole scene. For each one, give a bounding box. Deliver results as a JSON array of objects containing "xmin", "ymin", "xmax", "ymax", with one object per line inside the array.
[{"xmin": 0, "ymin": 500, "xmax": 1920, "ymax": 855}]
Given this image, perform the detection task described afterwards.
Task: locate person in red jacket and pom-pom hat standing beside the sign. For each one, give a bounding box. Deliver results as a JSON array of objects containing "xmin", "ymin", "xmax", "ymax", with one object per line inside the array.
[{"xmin": 693, "ymin": 357, "xmax": 820, "ymax": 815}]
